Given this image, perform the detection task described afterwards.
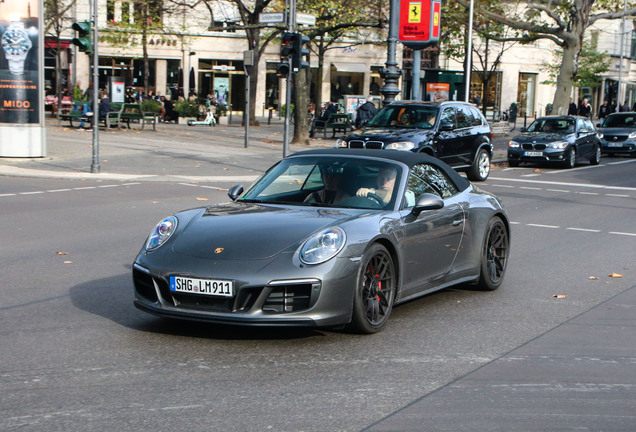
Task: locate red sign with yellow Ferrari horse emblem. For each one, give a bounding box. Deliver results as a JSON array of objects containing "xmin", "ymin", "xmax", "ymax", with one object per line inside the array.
[{"xmin": 398, "ymin": 0, "xmax": 441, "ymax": 49}]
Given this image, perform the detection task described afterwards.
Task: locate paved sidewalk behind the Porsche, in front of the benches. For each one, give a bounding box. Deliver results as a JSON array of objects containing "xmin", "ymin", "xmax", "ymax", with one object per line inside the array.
[{"xmin": 0, "ymin": 116, "xmax": 516, "ymax": 182}]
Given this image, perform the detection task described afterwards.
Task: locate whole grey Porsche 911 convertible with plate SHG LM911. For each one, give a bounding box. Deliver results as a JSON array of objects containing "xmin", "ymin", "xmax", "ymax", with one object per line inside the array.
[{"xmin": 133, "ymin": 150, "xmax": 510, "ymax": 333}]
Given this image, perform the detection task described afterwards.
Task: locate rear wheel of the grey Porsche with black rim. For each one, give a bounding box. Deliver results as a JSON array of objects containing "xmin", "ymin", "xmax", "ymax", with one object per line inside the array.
[{"xmin": 478, "ymin": 217, "xmax": 510, "ymax": 291}]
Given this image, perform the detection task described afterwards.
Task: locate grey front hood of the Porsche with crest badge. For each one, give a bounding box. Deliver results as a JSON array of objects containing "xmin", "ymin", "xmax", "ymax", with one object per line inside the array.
[{"xmin": 172, "ymin": 202, "xmax": 364, "ymax": 260}]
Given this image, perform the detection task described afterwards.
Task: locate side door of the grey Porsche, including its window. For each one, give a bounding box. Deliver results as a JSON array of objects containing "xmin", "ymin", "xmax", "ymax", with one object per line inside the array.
[{"xmin": 400, "ymin": 164, "xmax": 465, "ymax": 296}]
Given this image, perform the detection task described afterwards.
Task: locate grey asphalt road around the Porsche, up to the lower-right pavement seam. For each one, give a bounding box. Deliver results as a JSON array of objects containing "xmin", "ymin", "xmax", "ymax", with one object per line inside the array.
[{"xmin": 0, "ymin": 159, "xmax": 636, "ymax": 432}]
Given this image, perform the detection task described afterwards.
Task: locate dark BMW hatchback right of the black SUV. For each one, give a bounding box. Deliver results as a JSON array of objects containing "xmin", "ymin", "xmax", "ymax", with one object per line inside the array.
[{"xmin": 508, "ymin": 116, "xmax": 601, "ymax": 168}]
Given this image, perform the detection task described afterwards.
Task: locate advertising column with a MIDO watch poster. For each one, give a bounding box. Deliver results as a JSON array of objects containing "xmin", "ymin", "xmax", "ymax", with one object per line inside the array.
[{"xmin": 0, "ymin": 0, "xmax": 46, "ymax": 157}]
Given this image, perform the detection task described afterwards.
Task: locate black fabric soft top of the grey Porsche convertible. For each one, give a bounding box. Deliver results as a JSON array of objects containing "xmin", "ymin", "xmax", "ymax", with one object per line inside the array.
[{"xmin": 289, "ymin": 149, "xmax": 470, "ymax": 191}]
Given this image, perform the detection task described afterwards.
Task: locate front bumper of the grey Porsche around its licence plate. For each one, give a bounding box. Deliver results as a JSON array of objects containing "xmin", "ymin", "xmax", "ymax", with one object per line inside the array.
[{"xmin": 133, "ymin": 256, "xmax": 358, "ymax": 327}]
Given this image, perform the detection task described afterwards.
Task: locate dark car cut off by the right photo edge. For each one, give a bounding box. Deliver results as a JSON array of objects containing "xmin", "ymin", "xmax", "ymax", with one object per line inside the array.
[{"xmin": 598, "ymin": 112, "xmax": 636, "ymax": 155}]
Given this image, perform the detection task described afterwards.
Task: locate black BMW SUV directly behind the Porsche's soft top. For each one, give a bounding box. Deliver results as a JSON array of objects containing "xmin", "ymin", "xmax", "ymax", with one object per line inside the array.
[{"xmin": 336, "ymin": 101, "xmax": 492, "ymax": 181}]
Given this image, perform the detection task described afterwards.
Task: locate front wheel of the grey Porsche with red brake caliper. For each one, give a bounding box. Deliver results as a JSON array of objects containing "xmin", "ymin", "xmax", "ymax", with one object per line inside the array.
[{"xmin": 348, "ymin": 243, "xmax": 397, "ymax": 334}]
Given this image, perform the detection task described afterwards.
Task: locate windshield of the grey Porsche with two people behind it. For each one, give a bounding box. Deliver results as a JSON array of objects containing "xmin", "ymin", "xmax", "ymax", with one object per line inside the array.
[{"xmin": 237, "ymin": 156, "xmax": 402, "ymax": 209}]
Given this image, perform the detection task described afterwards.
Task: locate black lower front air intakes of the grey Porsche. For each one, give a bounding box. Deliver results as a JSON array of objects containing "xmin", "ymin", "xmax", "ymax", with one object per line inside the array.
[{"xmin": 133, "ymin": 268, "xmax": 320, "ymax": 313}]
